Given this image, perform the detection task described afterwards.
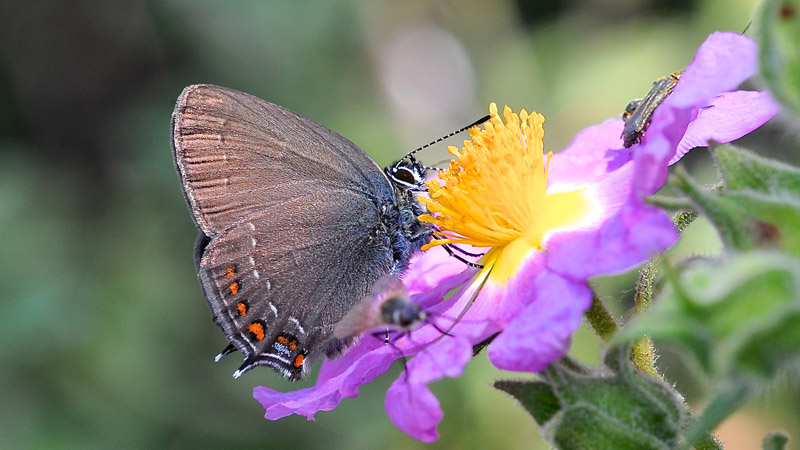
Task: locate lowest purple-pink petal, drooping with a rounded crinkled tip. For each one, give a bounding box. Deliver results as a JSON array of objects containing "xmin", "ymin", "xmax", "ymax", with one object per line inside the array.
[{"xmin": 386, "ymin": 337, "xmax": 472, "ymax": 442}]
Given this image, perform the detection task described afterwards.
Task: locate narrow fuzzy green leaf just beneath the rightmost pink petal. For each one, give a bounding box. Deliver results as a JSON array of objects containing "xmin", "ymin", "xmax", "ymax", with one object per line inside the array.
[{"xmin": 712, "ymin": 145, "xmax": 800, "ymax": 194}]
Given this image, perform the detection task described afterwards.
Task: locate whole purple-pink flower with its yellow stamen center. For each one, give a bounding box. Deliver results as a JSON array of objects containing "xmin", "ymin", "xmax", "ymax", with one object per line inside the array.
[{"xmin": 254, "ymin": 33, "xmax": 778, "ymax": 442}]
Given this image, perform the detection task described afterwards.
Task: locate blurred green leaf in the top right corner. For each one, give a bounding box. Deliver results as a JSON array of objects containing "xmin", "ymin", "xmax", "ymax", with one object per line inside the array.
[{"xmin": 757, "ymin": 0, "xmax": 800, "ymax": 118}]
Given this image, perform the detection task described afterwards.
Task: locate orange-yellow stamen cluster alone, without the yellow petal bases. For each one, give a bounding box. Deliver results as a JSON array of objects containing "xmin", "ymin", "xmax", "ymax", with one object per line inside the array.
[{"xmin": 420, "ymin": 103, "xmax": 552, "ymax": 253}]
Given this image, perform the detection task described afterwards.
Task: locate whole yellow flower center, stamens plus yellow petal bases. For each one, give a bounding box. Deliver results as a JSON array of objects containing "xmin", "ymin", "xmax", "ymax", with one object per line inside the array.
[{"xmin": 419, "ymin": 103, "xmax": 588, "ymax": 281}]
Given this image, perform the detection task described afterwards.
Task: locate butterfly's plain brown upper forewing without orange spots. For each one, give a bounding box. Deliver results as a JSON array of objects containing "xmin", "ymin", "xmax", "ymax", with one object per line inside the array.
[{"xmin": 172, "ymin": 85, "xmax": 388, "ymax": 236}]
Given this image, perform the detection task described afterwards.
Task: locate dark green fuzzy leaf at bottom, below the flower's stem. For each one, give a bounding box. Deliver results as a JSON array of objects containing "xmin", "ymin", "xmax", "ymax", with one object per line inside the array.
[{"xmin": 495, "ymin": 345, "xmax": 688, "ymax": 449}]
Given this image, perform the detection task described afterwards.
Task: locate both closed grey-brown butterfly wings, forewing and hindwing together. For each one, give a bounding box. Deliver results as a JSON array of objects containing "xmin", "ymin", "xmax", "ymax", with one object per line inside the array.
[{"xmin": 172, "ymin": 85, "xmax": 404, "ymax": 379}]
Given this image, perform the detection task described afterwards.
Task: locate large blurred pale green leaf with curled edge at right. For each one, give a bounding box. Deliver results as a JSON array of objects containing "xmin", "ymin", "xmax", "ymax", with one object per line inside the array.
[{"xmin": 615, "ymin": 251, "xmax": 800, "ymax": 380}]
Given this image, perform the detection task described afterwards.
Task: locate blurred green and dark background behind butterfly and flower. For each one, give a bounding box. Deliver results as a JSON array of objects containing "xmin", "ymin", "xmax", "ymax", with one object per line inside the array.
[{"xmin": 0, "ymin": 0, "xmax": 800, "ymax": 449}]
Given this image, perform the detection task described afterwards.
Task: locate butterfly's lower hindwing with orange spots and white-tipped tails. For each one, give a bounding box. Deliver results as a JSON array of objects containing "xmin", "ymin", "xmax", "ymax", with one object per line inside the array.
[{"xmin": 198, "ymin": 190, "xmax": 392, "ymax": 379}]
